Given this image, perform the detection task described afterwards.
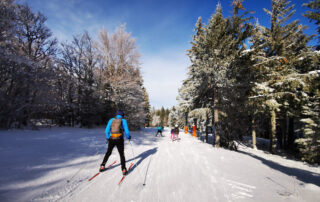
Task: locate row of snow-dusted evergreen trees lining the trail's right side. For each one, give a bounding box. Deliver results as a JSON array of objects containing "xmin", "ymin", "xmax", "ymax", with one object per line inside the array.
[{"xmin": 170, "ymin": 0, "xmax": 320, "ymax": 162}]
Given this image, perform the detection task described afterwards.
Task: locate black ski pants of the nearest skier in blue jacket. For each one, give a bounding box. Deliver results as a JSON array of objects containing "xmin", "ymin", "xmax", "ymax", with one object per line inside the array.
[{"xmin": 101, "ymin": 138, "xmax": 126, "ymax": 170}]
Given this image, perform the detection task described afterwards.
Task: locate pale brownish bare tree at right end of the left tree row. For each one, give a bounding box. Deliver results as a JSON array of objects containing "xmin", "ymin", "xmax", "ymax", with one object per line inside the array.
[{"xmin": 97, "ymin": 25, "xmax": 146, "ymax": 128}]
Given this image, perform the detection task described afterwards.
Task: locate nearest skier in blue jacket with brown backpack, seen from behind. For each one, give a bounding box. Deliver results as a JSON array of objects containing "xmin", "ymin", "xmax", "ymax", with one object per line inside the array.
[{"xmin": 100, "ymin": 110, "xmax": 131, "ymax": 175}]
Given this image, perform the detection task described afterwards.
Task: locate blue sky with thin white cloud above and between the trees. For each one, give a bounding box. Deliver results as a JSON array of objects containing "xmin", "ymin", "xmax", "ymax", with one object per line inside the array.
[{"xmin": 17, "ymin": 0, "xmax": 316, "ymax": 108}]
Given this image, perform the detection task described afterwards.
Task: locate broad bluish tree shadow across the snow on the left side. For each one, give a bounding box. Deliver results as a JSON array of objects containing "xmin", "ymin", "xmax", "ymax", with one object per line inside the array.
[{"xmin": 0, "ymin": 128, "xmax": 158, "ymax": 201}]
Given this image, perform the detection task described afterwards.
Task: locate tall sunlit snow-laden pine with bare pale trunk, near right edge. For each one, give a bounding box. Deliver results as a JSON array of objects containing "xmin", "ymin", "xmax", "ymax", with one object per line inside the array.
[{"xmin": 252, "ymin": 0, "xmax": 311, "ymax": 152}]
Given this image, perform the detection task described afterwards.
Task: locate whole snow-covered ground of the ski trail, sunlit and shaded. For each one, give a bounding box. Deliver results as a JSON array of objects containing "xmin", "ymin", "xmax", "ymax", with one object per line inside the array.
[{"xmin": 0, "ymin": 128, "xmax": 320, "ymax": 202}]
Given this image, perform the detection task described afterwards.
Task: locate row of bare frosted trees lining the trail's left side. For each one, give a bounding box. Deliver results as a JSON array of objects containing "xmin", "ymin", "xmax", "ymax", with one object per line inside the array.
[{"xmin": 0, "ymin": 0, "xmax": 149, "ymax": 129}]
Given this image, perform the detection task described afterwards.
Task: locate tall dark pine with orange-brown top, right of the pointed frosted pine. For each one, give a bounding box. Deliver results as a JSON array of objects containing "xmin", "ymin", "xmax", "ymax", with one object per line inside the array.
[{"xmin": 219, "ymin": 0, "xmax": 252, "ymax": 148}]
